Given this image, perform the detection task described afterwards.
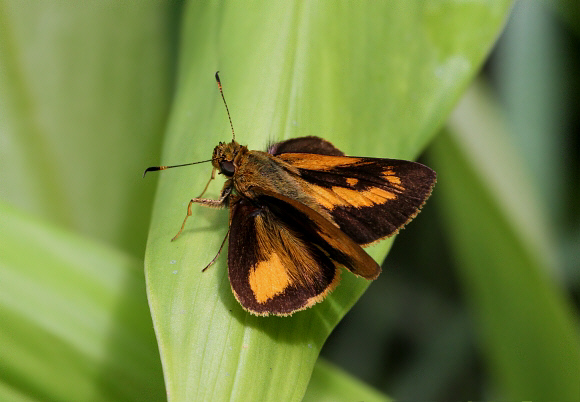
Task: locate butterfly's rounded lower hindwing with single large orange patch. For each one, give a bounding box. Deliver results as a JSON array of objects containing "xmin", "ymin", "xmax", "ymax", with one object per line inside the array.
[{"xmin": 228, "ymin": 198, "xmax": 339, "ymax": 315}]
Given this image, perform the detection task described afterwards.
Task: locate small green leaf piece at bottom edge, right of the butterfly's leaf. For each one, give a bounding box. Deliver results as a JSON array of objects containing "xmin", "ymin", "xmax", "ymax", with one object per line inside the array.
[{"xmin": 304, "ymin": 359, "xmax": 390, "ymax": 402}]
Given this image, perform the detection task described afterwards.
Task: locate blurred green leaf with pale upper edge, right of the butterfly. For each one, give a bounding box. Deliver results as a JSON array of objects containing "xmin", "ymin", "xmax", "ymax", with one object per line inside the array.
[{"xmin": 432, "ymin": 84, "xmax": 580, "ymax": 401}]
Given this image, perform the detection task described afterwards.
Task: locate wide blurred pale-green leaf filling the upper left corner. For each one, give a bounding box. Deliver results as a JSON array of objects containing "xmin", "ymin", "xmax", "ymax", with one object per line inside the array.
[{"xmin": 0, "ymin": 0, "xmax": 179, "ymax": 258}]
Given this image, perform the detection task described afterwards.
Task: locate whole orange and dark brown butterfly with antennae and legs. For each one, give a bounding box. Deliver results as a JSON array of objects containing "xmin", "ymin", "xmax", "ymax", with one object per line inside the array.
[{"xmin": 144, "ymin": 73, "xmax": 435, "ymax": 316}]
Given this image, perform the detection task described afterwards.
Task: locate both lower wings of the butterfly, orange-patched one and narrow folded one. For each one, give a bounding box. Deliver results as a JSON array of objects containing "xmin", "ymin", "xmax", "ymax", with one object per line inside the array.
[{"xmin": 228, "ymin": 188, "xmax": 380, "ymax": 315}]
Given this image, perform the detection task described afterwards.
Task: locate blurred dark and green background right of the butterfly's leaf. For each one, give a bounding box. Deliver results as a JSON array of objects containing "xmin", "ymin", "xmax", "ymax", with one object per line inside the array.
[{"xmin": 322, "ymin": 1, "xmax": 580, "ymax": 400}]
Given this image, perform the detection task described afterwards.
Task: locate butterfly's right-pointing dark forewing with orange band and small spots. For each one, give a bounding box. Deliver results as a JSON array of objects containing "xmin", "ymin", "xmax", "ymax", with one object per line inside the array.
[{"xmin": 277, "ymin": 153, "xmax": 435, "ymax": 245}]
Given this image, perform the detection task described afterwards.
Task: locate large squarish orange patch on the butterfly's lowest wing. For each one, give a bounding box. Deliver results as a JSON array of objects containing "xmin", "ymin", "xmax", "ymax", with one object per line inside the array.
[{"xmin": 249, "ymin": 253, "xmax": 292, "ymax": 303}]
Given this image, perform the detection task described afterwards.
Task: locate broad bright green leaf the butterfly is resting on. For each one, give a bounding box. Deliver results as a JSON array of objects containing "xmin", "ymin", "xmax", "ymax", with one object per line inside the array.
[{"xmin": 145, "ymin": 1, "xmax": 509, "ymax": 400}]
